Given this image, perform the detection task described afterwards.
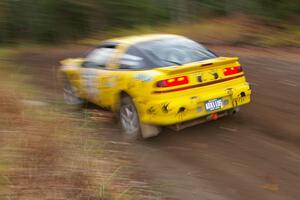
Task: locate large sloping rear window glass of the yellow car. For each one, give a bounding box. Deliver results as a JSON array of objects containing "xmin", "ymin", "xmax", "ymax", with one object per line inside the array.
[{"xmin": 136, "ymin": 37, "xmax": 216, "ymax": 67}]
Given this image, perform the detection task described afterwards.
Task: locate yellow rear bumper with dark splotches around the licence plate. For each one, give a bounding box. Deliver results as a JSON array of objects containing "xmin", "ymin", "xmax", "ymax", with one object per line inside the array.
[{"xmin": 137, "ymin": 82, "xmax": 251, "ymax": 126}]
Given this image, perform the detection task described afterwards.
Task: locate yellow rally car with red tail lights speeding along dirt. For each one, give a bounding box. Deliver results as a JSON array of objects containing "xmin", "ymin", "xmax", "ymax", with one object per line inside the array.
[{"xmin": 61, "ymin": 34, "xmax": 251, "ymax": 138}]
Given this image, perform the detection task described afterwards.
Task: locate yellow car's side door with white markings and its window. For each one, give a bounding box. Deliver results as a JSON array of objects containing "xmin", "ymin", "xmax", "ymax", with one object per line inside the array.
[{"xmin": 80, "ymin": 45, "xmax": 116, "ymax": 106}]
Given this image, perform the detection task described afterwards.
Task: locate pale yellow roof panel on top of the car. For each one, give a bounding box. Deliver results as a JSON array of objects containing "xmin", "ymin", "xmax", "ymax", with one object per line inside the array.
[{"xmin": 104, "ymin": 34, "xmax": 183, "ymax": 45}]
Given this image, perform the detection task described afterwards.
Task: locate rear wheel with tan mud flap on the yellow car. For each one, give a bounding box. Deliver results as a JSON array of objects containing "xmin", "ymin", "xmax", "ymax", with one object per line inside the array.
[{"xmin": 119, "ymin": 96, "xmax": 160, "ymax": 139}]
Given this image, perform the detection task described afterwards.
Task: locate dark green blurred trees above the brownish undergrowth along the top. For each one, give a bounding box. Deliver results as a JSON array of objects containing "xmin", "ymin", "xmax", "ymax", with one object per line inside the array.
[{"xmin": 0, "ymin": 0, "xmax": 300, "ymax": 42}]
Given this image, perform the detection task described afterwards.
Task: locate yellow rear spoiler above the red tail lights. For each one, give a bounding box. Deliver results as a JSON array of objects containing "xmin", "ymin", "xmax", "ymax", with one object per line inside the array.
[{"xmin": 155, "ymin": 57, "xmax": 239, "ymax": 75}]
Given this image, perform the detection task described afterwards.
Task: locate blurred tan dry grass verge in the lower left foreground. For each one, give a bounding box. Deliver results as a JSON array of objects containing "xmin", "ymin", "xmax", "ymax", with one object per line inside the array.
[{"xmin": 0, "ymin": 49, "xmax": 164, "ymax": 200}]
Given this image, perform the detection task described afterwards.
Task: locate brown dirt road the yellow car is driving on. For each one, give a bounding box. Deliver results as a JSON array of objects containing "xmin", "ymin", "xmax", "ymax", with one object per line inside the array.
[{"xmin": 18, "ymin": 46, "xmax": 300, "ymax": 200}]
